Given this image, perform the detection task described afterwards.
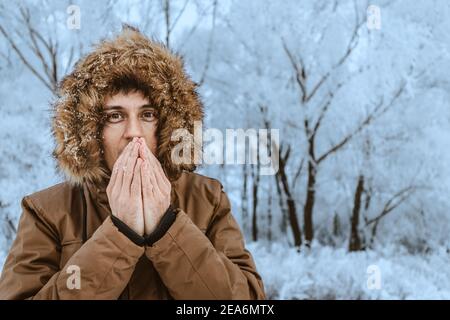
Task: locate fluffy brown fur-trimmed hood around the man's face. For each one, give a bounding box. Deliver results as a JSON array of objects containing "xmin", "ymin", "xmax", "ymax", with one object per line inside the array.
[{"xmin": 53, "ymin": 27, "xmax": 203, "ymax": 184}]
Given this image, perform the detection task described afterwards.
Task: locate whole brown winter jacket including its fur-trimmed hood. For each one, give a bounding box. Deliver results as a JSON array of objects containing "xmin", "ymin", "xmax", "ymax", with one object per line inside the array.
[{"xmin": 0, "ymin": 28, "xmax": 265, "ymax": 299}]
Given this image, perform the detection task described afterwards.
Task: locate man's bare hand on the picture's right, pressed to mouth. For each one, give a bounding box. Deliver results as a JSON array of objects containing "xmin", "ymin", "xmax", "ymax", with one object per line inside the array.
[{"xmin": 139, "ymin": 140, "xmax": 172, "ymax": 235}]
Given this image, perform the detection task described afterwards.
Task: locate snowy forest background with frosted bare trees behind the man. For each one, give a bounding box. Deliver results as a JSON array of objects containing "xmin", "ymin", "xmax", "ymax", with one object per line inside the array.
[{"xmin": 0, "ymin": 0, "xmax": 450, "ymax": 299}]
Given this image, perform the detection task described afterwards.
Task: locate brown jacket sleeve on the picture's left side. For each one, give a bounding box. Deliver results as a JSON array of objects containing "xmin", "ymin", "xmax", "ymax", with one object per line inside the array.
[{"xmin": 0, "ymin": 197, "xmax": 144, "ymax": 299}]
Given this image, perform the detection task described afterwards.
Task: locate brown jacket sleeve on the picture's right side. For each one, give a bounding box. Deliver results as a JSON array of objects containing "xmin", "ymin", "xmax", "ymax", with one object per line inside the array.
[{"xmin": 145, "ymin": 190, "xmax": 265, "ymax": 300}]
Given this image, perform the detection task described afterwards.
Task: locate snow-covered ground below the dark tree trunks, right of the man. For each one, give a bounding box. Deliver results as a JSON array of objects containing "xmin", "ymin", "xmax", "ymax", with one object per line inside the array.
[{"xmin": 247, "ymin": 242, "xmax": 450, "ymax": 299}]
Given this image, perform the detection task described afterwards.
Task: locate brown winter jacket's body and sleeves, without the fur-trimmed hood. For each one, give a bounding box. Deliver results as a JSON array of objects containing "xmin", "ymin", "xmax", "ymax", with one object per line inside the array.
[{"xmin": 0, "ymin": 173, "xmax": 265, "ymax": 299}]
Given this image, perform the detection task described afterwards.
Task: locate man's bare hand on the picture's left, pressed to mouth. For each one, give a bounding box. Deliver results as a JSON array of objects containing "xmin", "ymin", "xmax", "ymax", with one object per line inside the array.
[{"xmin": 106, "ymin": 138, "xmax": 145, "ymax": 236}]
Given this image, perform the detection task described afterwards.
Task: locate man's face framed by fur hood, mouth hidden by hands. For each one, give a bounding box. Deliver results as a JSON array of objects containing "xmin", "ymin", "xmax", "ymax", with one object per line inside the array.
[{"xmin": 102, "ymin": 91, "xmax": 158, "ymax": 171}]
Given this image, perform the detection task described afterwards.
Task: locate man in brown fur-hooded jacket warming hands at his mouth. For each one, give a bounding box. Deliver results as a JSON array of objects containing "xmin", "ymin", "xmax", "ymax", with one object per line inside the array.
[{"xmin": 0, "ymin": 28, "xmax": 265, "ymax": 299}]
